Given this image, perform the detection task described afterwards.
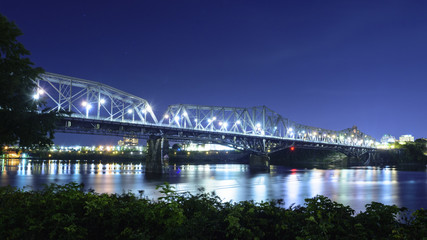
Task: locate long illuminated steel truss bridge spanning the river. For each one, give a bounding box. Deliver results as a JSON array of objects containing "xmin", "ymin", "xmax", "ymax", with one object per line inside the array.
[{"xmin": 33, "ymin": 73, "xmax": 375, "ymax": 155}]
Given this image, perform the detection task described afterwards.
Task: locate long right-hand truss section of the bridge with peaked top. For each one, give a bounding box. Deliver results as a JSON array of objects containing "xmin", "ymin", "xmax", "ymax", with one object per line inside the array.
[{"xmin": 159, "ymin": 104, "xmax": 375, "ymax": 152}]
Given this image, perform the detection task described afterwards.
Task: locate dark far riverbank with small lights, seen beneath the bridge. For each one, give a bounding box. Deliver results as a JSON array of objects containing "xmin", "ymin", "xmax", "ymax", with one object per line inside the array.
[{"xmin": 11, "ymin": 149, "xmax": 427, "ymax": 170}]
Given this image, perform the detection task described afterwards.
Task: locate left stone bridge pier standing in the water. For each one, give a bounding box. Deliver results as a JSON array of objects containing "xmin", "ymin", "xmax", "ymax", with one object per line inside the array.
[{"xmin": 145, "ymin": 136, "xmax": 169, "ymax": 173}]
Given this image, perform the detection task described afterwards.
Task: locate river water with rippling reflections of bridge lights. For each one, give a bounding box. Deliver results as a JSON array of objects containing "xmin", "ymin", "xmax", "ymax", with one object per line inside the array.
[{"xmin": 0, "ymin": 159, "xmax": 427, "ymax": 212}]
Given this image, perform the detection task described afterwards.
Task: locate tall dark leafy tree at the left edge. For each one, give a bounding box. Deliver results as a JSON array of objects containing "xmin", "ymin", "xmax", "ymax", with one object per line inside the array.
[{"xmin": 0, "ymin": 14, "xmax": 58, "ymax": 153}]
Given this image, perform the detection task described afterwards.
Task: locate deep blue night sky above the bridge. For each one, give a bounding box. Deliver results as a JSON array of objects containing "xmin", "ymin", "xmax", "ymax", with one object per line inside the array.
[{"xmin": 0, "ymin": 0, "xmax": 427, "ymax": 144}]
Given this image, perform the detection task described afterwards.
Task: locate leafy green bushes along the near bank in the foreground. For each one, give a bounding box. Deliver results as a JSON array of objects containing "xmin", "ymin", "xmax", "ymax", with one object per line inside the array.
[{"xmin": 0, "ymin": 183, "xmax": 427, "ymax": 240}]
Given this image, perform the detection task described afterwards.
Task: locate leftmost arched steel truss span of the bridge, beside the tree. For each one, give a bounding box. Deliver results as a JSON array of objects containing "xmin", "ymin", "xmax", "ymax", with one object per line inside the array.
[{"xmin": 34, "ymin": 73, "xmax": 158, "ymax": 124}]
